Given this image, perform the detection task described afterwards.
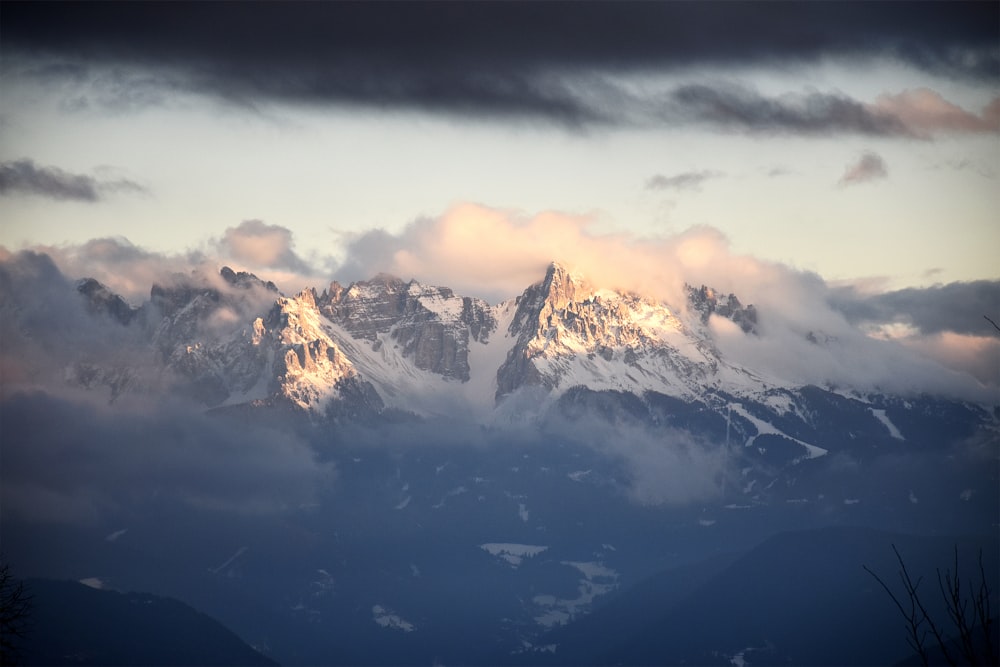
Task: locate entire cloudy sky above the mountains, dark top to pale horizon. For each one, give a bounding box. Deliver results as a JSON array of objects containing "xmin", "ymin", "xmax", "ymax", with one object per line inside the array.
[{"xmin": 0, "ymin": 2, "xmax": 1000, "ymax": 289}]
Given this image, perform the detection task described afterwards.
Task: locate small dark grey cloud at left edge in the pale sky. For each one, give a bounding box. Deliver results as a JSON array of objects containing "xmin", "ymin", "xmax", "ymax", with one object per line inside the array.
[{"xmin": 0, "ymin": 159, "xmax": 145, "ymax": 202}]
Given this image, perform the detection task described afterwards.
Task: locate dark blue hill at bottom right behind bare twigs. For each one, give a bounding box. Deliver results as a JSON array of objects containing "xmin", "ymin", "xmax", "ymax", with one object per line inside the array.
[{"xmin": 539, "ymin": 527, "xmax": 998, "ymax": 665}]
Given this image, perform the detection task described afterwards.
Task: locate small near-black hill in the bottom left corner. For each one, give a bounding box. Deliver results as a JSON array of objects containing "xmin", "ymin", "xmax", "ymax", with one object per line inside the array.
[{"xmin": 20, "ymin": 579, "xmax": 277, "ymax": 665}]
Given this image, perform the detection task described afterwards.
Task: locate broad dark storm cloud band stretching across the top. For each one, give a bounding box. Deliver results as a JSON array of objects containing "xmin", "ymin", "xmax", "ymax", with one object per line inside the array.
[{"xmin": 3, "ymin": 2, "xmax": 1000, "ymax": 125}]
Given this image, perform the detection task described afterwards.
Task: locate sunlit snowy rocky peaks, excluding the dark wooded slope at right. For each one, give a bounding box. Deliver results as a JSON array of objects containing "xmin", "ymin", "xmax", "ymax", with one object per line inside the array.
[{"xmin": 60, "ymin": 263, "xmax": 796, "ymax": 417}]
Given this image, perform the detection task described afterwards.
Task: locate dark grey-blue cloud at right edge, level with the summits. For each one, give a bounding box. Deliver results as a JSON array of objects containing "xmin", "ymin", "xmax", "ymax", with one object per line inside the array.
[{"xmin": 831, "ymin": 280, "xmax": 1000, "ymax": 336}]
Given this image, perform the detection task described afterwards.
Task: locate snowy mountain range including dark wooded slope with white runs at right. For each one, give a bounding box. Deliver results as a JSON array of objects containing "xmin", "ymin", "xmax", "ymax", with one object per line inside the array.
[{"xmin": 35, "ymin": 263, "xmax": 988, "ymax": 480}]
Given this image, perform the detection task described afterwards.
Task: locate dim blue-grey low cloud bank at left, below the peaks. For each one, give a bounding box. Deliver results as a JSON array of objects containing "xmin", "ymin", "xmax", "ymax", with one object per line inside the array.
[{"xmin": 0, "ymin": 392, "xmax": 333, "ymax": 523}]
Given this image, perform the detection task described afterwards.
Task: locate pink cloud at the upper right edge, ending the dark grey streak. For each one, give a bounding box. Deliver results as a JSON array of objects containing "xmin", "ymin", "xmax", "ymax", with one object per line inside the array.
[{"xmin": 872, "ymin": 88, "xmax": 1000, "ymax": 137}]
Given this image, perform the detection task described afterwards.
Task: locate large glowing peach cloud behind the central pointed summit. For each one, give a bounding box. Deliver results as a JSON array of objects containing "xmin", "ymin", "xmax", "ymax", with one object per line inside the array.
[{"xmin": 341, "ymin": 203, "xmax": 782, "ymax": 310}]
